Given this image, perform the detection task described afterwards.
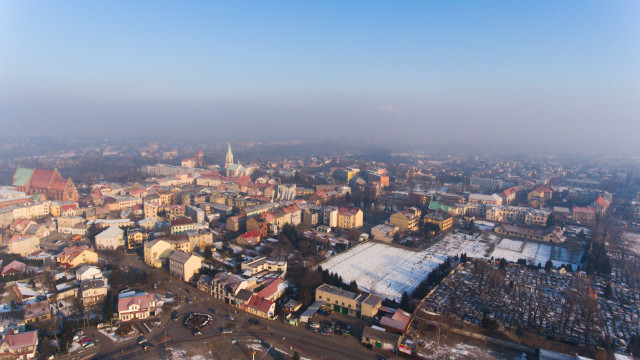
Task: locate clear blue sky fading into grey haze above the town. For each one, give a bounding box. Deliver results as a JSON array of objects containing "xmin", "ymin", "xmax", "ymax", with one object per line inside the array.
[{"xmin": 0, "ymin": 1, "xmax": 640, "ymax": 152}]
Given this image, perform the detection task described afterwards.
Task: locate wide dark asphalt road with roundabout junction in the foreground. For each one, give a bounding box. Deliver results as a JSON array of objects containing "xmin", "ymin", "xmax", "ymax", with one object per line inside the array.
[{"xmin": 74, "ymin": 255, "xmax": 380, "ymax": 360}]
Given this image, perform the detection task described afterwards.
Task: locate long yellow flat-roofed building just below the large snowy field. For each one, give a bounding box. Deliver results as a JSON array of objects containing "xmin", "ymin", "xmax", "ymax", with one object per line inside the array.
[{"xmin": 316, "ymin": 284, "xmax": 382, "ymax": 319}]
